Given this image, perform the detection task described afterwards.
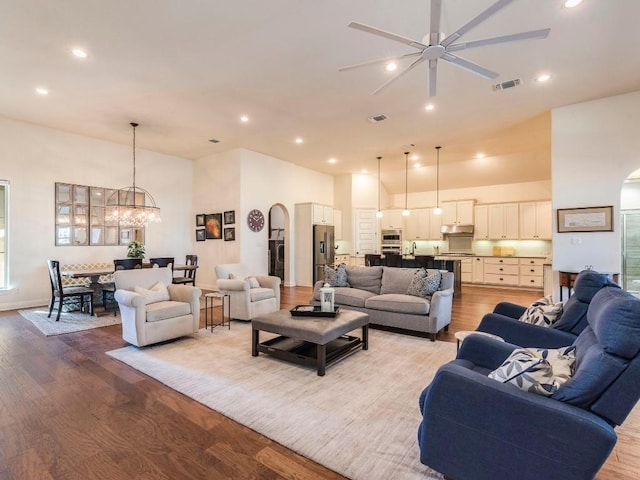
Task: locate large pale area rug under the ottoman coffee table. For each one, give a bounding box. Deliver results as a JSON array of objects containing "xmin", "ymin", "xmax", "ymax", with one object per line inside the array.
[{"xmin": 108, "ymin": 322, "xmax": 456, "ymax": 480}]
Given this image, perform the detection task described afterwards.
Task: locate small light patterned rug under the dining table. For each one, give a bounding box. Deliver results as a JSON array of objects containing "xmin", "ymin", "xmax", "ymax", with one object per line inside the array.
[{"xmin": 18, "ymin": 307, "xmax": 122, "ymax": 337}]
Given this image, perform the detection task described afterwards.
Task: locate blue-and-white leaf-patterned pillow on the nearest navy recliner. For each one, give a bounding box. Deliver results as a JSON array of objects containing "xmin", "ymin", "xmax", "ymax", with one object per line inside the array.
[{"xmin": 489, "ymin": 346, "xmax": 576, "ymax": 397}]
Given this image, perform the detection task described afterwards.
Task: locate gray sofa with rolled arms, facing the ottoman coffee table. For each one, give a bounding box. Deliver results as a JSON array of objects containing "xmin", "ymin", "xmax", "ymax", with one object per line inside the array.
[{"xmin": 311, "ymin": 266, "xmax": 453, "ymax": 341}]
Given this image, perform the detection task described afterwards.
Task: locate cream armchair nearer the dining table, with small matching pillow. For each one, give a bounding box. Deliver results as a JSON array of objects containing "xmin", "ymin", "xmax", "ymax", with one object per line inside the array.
[{"xmin": 113, "ymin": 268, "xmax": 202, "ymax": 347}]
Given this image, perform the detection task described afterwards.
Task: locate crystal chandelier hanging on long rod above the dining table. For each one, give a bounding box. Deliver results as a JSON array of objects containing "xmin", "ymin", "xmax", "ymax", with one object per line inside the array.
[{"xmin": 105, "ymin": 122, "xmax": 161, "ymax": 228}]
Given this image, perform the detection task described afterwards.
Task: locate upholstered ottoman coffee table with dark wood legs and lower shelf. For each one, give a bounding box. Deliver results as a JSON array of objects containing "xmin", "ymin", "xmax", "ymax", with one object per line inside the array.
[{"xmin": 251, "ymin": 309, "xmax": 369, "ymax": 376}]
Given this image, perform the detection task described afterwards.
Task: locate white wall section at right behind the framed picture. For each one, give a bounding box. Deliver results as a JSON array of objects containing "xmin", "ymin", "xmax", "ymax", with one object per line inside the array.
[{"xmin": 551, "ymin": 92, "xmax": 640, "ymax": 272}]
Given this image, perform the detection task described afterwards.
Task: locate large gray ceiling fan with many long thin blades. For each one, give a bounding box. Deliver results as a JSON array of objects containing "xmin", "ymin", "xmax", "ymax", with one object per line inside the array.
[{"xmin": 338, "ymin": 0, "xmax": 551, "ymax": 97}]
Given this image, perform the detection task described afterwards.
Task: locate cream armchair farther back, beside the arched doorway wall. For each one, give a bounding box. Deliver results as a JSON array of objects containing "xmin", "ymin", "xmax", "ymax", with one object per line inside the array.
[{"xmin": 216, "ymin": 263, "xmax": 281, "ymax": 320}]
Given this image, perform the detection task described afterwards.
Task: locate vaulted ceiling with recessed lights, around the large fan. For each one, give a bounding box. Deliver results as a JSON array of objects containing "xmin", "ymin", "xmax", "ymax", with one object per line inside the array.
[{"xmin": 0, "ymin": 0, "xmax": 640, "ymax": 193}]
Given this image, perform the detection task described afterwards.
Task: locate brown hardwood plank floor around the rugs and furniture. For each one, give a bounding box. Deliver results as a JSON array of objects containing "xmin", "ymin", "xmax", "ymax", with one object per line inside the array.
[{"xmin": 0, "ymin": 286, "xmax": 640, "ymax": 480}]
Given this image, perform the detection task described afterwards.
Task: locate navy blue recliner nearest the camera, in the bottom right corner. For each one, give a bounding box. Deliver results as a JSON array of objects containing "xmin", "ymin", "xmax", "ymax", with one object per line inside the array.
[{"xmin": 418, "ymin": 288, "xmax": 640, "ymax": 480}]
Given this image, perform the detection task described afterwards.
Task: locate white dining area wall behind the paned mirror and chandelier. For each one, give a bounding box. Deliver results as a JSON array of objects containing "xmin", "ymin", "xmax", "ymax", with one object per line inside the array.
[{"xmin": 0, "ymin": 118, "xmax": 193, "ymax": 310}]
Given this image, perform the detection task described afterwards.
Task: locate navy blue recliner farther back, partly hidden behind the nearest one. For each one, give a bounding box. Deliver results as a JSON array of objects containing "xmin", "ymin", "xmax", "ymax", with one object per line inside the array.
[{"xmin": 477, "ymin": 270, "xmax": 617, "ymax": 348}]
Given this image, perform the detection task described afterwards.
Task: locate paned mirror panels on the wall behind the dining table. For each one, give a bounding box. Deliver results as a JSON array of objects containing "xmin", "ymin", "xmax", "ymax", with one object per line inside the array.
[{"xmin": 55, "ymin": 183, "xmax": 144, "ymax": 246}]
